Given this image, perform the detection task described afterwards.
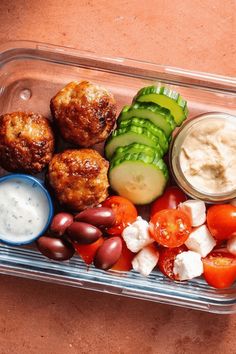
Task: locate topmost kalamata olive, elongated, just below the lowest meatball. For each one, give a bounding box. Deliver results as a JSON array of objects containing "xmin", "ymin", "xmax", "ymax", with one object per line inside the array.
[{"xmin": 75, "ymin": 207, "xmax": 115, "ymax": 228}]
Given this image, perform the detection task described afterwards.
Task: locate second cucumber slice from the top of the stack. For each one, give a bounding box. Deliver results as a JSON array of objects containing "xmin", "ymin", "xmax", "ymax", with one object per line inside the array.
[{"xmin": 118, "ymin": 102, "xmax": 176, "ymax": 137}]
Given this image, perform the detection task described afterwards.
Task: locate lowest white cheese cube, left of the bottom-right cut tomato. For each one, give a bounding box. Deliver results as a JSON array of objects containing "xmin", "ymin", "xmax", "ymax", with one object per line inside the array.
[{"xmin": 173, "ymin": 251, "xmax": 203, "ymax": 280}]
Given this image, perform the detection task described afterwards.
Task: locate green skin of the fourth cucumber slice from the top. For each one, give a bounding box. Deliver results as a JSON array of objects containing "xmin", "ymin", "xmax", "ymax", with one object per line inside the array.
[{"xmin": 105, "ymin": 126, "xmax": 164, "ymax": 160}]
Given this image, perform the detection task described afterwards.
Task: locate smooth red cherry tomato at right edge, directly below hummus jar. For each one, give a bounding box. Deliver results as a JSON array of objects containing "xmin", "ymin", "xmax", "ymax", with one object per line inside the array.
[{"xmin": 207, "ymin": 204, "xmax": 236, "ymax": 240}]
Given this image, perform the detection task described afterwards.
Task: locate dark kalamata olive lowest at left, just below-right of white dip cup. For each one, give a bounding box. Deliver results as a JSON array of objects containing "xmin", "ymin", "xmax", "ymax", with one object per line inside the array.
[{"xmin": 36, "ymin": 236, "xmax": 75, "ymax": 261}]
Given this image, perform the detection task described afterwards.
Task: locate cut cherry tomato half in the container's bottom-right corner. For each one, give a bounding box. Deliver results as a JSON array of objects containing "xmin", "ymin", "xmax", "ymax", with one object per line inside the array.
[{"xmin": 202, "ymin": 249, "xmax": 236, "ymax": 289}]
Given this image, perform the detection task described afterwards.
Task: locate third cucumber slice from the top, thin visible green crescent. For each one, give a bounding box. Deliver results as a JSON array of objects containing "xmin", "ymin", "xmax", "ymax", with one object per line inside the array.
[{"xmin": 119, "ymin": 118, "xmax": 170, "ymax": 153}]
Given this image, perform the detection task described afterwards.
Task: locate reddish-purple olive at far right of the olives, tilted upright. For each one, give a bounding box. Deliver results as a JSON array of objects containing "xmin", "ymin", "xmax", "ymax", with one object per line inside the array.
[{"xmin": 94, "ymin": 236, "xmax": 122, "ymax": 270}]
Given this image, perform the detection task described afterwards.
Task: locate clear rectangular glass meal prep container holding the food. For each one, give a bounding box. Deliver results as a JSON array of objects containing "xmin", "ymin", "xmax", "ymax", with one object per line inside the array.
[{"xmin": 0, "ymin": 41, "xmax": 236, "ymax": 314}]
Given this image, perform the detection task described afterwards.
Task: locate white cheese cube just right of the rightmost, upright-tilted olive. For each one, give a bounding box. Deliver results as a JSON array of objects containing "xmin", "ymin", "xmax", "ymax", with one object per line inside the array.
[{"xmin": 132, "ymin": 245, "xmax": 159, "ymax": 277}]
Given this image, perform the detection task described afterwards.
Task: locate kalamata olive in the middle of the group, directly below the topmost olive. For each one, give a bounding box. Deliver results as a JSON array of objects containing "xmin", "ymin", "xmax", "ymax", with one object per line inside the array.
[{"xmin": 66, "ymin": 221, "xmax": 102, "ymax": 245}]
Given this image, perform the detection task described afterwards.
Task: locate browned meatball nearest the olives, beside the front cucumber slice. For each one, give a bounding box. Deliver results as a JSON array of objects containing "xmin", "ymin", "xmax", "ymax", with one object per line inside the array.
[{"xmin": 48, "ymin": 149, "xmax": 109, "ymax": 211}]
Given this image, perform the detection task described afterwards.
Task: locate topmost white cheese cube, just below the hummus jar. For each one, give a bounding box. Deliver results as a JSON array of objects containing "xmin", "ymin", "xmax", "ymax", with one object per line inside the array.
[{"xmin": 178, "ymin": 200, "xmax": 206, "ymax": 227}]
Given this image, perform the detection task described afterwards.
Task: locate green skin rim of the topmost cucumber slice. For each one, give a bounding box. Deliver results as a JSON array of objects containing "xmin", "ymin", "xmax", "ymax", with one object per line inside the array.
[{"xmin": 134, "ymin": 85, "xmax": 188, "ymax": 126}]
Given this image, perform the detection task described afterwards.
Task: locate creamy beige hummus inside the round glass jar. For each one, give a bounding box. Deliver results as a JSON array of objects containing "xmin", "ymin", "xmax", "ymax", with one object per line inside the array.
[{"xmin": 179, "ymin": 115, "xmax": 236, "ymax": 194}]
